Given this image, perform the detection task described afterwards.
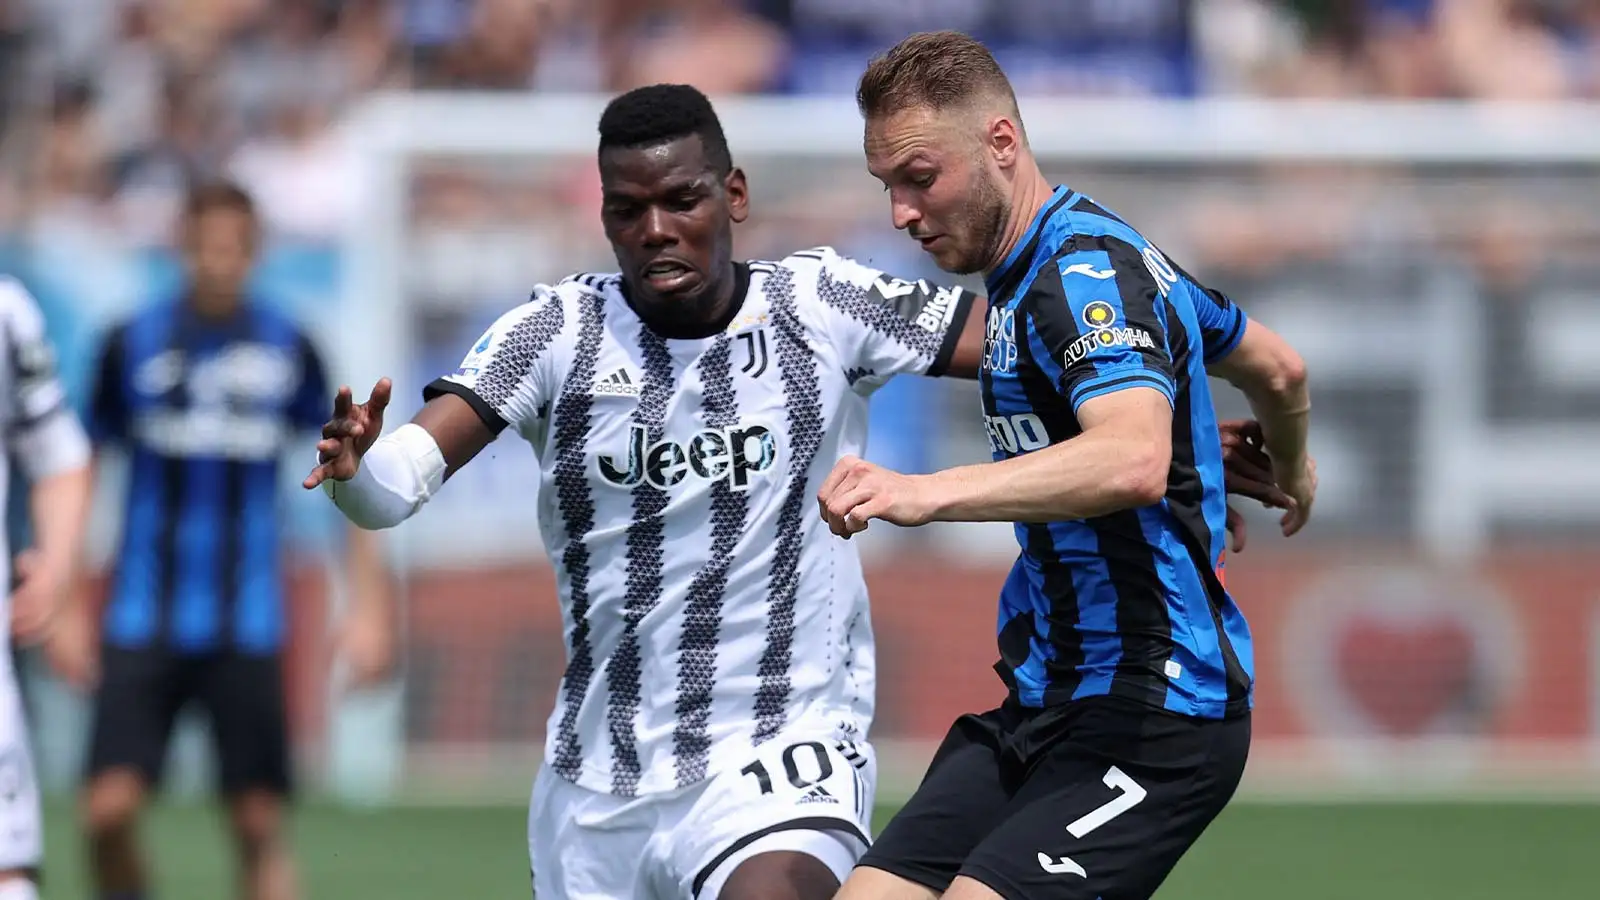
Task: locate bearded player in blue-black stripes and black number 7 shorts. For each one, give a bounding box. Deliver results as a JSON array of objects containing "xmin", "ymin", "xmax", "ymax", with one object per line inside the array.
[{"xmin": 821, "ymin": 32, "xmax": 1317, "ymax": 900}]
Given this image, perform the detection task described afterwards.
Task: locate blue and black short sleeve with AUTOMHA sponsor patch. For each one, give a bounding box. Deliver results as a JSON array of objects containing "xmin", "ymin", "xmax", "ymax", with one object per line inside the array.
[{"xmin": 1026, "ymin": 237, "xmax": 1178, "ymax": 412}]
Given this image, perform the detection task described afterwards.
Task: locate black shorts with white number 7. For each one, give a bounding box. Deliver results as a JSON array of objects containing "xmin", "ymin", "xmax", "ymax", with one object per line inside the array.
[{"xmin": 859, "ymin": 697, "xmax": 1250, "ymax": 900}]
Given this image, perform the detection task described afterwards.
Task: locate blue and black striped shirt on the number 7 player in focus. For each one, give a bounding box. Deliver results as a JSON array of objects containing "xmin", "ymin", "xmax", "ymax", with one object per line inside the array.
[{"xmin": 981, "ymin": 187, "xmax": 1253, "ymax": 717}]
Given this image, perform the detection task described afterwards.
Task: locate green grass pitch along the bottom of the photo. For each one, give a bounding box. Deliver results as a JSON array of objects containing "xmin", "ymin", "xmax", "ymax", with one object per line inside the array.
[{"xmin": 34, "ymin": 794, "xmax": 1600, "ymax": 900}]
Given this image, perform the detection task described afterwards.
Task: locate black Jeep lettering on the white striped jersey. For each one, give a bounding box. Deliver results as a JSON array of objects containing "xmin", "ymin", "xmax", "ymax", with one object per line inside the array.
[{"xmin": 595, "ymin": 424, "xmax": 778, "ymax": 490}]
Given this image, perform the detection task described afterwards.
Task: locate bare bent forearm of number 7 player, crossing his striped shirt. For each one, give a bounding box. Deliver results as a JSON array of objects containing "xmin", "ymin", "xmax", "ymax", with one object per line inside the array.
[{"xmin": 925, "ymin": 431, "xmax": 1171, "ymax": 522}]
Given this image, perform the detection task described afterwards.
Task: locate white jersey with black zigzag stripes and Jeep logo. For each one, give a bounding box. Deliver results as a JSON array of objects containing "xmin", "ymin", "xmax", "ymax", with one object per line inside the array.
[{"xmin": 424, "ymin": 248, "xmax": 973, "ymax": 796}]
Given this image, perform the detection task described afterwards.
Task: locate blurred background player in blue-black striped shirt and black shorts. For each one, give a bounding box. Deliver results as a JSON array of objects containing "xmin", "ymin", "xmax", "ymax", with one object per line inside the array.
[{"xmin": 54, "ymin": 183, "xmax": 394, "ymax": 900}]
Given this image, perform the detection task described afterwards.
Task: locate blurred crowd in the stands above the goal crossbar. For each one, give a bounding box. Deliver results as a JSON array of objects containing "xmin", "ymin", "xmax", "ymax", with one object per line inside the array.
[{"xmin": 0, "ymin": 0, "xmax": 1600, "ymax": 243}]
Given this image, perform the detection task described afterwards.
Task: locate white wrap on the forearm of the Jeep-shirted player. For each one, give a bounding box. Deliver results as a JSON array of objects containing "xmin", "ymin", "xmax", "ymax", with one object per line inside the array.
[{"xmin": 322, "ymin": 423, "xmax": 445, "ymax": 532}]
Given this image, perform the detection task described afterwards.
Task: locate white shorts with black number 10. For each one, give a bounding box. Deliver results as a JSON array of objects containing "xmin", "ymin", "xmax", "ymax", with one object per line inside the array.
[{"xmin": 528, "ymin": 727, "xmax": 878, "ymax": 900}]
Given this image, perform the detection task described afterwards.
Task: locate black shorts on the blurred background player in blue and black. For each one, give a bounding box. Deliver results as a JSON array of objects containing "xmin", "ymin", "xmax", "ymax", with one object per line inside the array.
[{"xmin": 88, "ymin": 647, "xmax": 290, "ymax": 796}]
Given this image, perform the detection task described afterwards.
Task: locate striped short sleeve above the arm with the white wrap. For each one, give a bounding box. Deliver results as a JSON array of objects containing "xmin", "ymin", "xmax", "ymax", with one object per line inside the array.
[{"xmin": 422, "ymin": 287, "xmax": 566, "ymax": 434}]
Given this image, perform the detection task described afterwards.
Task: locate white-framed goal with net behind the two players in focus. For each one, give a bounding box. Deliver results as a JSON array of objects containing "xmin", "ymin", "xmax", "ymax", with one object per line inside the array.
[{"xmin": 330, "ymin": 94, "xmax": 1600, "ymax": 802}]
